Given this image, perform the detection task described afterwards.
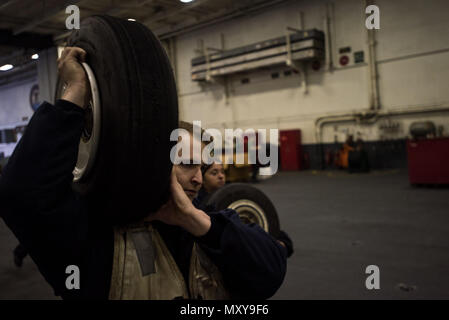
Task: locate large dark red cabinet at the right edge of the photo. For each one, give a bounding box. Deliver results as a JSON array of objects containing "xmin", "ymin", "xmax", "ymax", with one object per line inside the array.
[{"xmin": 407, "ymin": 138, "xmax": 449, "ymax": 184}]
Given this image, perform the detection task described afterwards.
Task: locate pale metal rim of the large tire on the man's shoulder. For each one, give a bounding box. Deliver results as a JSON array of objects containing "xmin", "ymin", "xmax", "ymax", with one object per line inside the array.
[{"xmin": 58, "ymin": 62, "xmax": 101, "ymax": 182}]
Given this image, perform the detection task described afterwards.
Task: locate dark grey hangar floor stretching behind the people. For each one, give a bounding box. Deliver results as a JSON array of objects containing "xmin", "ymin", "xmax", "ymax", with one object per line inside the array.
[{"xmin": 0, "ymin": 171, "xmax": 449, "ymax": 299}]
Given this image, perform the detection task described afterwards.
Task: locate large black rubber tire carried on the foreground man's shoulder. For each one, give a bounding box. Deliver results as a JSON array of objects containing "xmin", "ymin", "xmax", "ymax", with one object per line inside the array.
[{"xmin": 57, "ymin": 16, "xmax": 178, "ymax": 224}]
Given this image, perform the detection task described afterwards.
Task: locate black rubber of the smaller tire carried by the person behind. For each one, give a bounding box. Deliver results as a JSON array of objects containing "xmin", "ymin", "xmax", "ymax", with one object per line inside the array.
[{"xmin": 203, "ymin": 183, "xmax": 280, "ymax": 238}]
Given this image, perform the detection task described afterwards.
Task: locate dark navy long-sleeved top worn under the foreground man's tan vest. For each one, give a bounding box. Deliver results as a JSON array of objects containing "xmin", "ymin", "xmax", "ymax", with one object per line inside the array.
[{"xmin": 0, "ymin": 100, "xmax": 287, "ymax": 299}]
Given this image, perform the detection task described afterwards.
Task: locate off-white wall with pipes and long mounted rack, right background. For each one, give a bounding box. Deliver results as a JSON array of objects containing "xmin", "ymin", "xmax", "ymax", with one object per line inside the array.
[{"xmin": 176, "ymin": 0, "xmax": 449, "ymax": 143}]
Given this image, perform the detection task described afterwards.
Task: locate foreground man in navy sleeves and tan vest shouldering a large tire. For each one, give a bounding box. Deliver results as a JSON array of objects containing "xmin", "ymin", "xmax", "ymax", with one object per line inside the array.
[{"xmin": 0, "ymin": 48, "xmax": 287, "ymax": 299}]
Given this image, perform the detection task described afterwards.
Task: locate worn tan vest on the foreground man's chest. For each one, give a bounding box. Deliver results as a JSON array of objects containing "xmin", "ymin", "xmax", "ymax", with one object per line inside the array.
[{"xmin": 109, "ymin": 224, "xmax": 229, "ymax": 300}]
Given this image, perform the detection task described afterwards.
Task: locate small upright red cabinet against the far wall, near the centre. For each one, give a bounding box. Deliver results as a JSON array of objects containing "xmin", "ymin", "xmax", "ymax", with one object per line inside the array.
[{"xmin": 280, "ymin": 130, "xmax": 302, "ymax": 170}]
